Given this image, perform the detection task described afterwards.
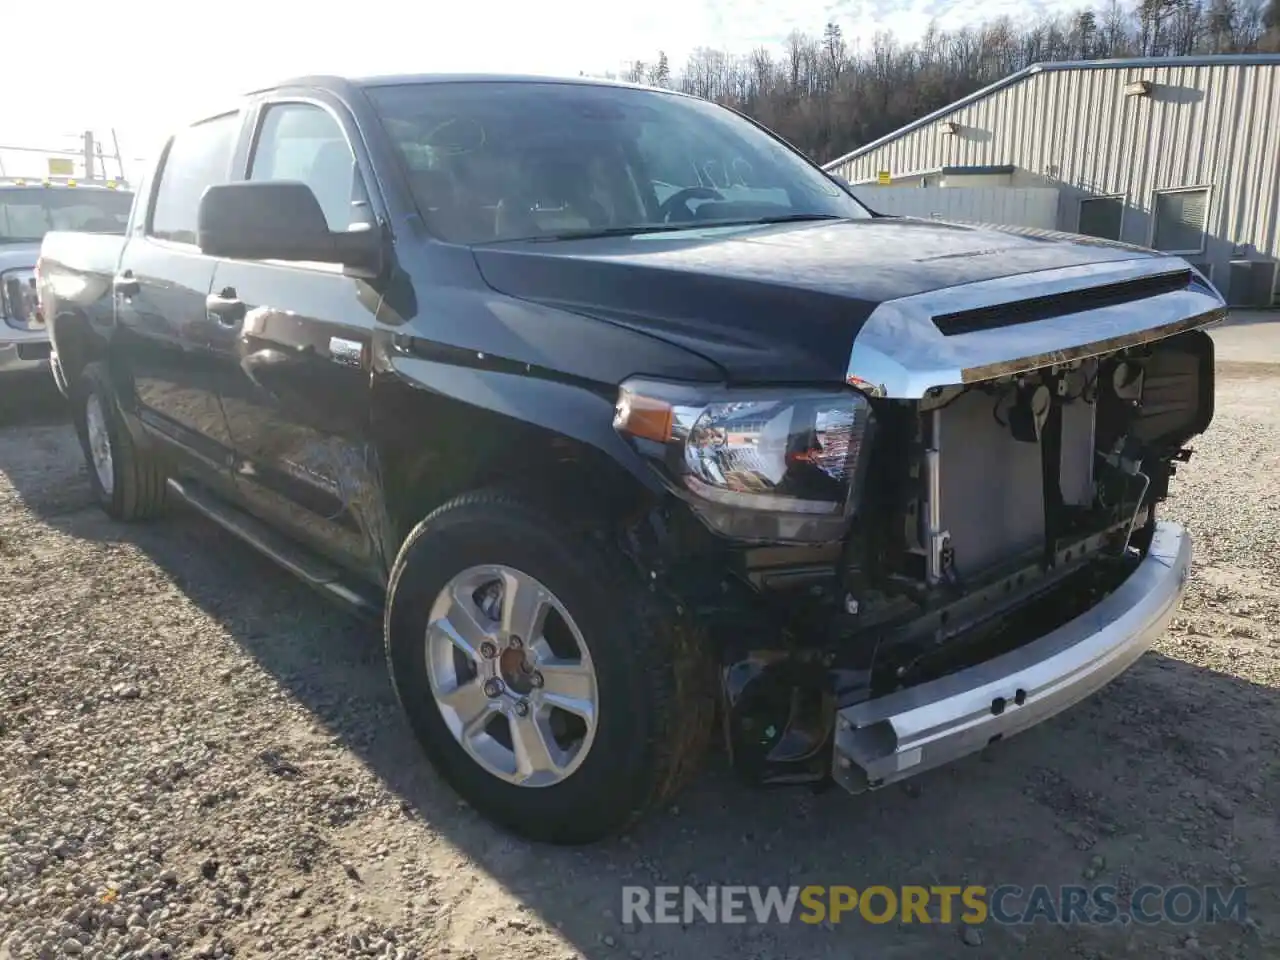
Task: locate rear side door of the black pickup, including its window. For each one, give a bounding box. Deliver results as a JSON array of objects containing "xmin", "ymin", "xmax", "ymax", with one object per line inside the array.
[{"xmin": 114, "ymin": 113, "xmax": 241, "ymax": 490}]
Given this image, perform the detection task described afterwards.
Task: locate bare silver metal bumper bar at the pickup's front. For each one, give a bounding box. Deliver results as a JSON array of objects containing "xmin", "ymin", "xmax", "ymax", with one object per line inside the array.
[{"xmin": 832, "ymin": 521, "xmax": 1192, "ymax": 794}]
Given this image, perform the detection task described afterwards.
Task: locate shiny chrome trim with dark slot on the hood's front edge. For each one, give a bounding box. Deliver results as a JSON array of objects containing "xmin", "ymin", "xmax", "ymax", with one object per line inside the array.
[{"xmin": 849, "ymin": 255, "xmax": 1226, "ymax": 399}]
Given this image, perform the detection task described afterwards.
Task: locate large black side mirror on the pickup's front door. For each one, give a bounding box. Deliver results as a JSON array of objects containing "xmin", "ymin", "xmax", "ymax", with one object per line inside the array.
[{"xmin": 196, "ymin": 180, "xmax": 383, "ymax": 275}]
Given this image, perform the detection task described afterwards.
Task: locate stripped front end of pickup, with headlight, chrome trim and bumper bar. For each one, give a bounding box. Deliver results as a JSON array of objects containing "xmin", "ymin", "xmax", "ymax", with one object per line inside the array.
[{"xmin": 618, "ymin": 257, "xmax": 1225, "ymax": 792}]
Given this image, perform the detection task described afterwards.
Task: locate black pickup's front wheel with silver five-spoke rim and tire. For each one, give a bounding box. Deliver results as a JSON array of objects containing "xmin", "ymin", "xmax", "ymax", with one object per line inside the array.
[{"xmin": 385, "ymin": 493, "xmax": 713, "ymax": 844}]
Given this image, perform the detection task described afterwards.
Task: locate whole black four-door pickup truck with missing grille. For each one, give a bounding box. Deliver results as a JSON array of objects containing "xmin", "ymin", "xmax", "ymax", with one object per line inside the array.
[{"xmin": 37, "ymin": 76, "xmax": 1225, "ymax": 842}]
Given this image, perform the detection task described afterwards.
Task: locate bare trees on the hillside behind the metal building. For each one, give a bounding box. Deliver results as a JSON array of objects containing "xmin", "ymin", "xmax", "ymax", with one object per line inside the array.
[{"xmin": 623, "ymin": 0, "xmax": 1280, "ymax": 161}]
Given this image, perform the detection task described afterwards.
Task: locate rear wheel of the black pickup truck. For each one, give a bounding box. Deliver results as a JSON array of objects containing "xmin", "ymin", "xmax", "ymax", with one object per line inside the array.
[{"xmin": 72, "ymin": 362, "xmax": 168, "ymax": 522}]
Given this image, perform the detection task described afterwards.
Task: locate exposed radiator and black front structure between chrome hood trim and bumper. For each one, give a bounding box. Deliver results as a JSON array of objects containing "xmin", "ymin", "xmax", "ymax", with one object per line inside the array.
[{"xmin": 712, "ymin": 330, "xmax": 1213, "ymax": 785}]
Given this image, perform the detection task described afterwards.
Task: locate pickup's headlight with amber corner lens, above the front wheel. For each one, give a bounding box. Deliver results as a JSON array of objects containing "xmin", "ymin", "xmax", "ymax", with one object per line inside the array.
[{"xmin": 613, "ymin": 380, "xmax": 874, "ymax": 543}]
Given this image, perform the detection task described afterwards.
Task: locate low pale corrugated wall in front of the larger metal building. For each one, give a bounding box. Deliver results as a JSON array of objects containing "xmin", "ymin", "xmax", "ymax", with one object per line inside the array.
[{"xmin": 854, "ymin": 187, "xmax": 1057, "ymax": 230}]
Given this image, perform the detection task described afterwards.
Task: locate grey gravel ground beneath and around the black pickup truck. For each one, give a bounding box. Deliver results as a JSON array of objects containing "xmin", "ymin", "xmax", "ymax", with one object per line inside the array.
[{"xmin": 0, "ymin": 362, "xmax": 1280, "ymax": 960}]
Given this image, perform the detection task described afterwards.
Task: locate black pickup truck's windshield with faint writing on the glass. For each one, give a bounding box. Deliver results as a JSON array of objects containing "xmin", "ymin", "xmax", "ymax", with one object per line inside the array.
[{"xmin": 369, "ymin": 82, "xmax": 870, "ymax": 243}]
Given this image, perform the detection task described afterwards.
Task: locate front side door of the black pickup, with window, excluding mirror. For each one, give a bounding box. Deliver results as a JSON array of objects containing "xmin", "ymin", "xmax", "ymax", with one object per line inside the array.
[{"xmin": 202, "ymin": 99, "xmax": 383, "ymax": 576}]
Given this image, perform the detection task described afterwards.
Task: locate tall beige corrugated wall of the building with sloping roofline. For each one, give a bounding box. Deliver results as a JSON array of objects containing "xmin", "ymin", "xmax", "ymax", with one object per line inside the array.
[{"xmin": 832, "ymin": 63, "xmax": 1280, "ymax": 300}]
